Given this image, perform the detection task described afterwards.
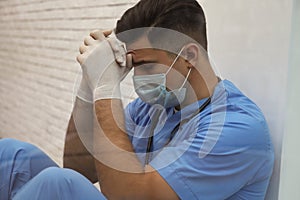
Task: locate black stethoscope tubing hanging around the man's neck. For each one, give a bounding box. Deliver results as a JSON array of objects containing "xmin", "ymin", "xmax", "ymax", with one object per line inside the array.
[{"xmin": 145, "ymin": 97, "xmax": 211, "ymax": 165}]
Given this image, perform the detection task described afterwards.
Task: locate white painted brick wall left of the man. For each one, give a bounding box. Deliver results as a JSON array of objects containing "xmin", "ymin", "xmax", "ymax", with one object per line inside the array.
[{"xmin": 0, "ymin": 0, "xmax": 136, "ymax": 164}]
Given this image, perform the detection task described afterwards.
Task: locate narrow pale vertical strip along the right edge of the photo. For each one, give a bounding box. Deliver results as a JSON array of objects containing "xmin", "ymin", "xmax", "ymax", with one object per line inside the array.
[{"xmin": 279, "ymin": 0, "xmax": 300, "ymax": 200}]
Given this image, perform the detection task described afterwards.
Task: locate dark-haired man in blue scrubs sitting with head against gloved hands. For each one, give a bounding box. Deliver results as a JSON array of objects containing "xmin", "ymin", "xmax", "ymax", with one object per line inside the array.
[{"xmin": 0, "ymin": 0, "xmax": 274, "ymax": 199}]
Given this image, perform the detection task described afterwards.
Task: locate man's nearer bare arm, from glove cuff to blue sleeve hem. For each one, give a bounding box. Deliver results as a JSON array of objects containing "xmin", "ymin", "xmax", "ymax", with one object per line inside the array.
[{"xmin": 94, "ymin": 100, "xmax": 178, "ymax": 199}]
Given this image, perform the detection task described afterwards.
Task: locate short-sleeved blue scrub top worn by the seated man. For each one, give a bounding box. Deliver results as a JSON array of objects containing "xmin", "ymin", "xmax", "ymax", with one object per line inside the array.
[{"xmin": 125, "ymin": 80, "xmax": 274, "ymax": 200}]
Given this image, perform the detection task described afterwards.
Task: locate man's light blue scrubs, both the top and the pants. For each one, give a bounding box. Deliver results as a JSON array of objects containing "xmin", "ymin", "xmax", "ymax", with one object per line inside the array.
[{"xmin": 0, "ymin": 81, "xmax": 274, "ymax": 200}]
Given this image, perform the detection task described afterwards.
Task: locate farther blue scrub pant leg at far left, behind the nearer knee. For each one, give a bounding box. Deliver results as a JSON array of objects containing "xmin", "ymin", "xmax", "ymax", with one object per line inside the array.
[{"xmin": 0, "ymin": 139, "xmax": 58, "ymax": 200}]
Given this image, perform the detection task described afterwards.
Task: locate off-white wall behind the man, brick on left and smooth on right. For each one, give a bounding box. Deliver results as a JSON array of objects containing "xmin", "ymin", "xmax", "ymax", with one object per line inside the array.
[{"xmin": 0, "ymin": 0, "xmax": 299, "ymax": 200}]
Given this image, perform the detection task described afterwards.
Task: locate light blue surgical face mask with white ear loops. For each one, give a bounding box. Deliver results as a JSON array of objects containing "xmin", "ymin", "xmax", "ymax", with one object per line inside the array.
[{"xmin": 133, "ymin": 48, "xmax": 191, "ymax": 108}]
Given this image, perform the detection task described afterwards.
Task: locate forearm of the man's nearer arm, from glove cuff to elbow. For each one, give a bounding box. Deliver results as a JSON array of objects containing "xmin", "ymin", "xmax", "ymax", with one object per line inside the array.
[{"xmin": 94, "ymin": 100, "xmax": 147, "ymax": 199}]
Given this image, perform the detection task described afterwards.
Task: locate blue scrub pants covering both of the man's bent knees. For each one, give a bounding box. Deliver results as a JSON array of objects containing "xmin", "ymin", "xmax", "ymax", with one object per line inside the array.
[{"xmin": 0, "ymin": 139, "xmax": 105, "ymax": 200}]
